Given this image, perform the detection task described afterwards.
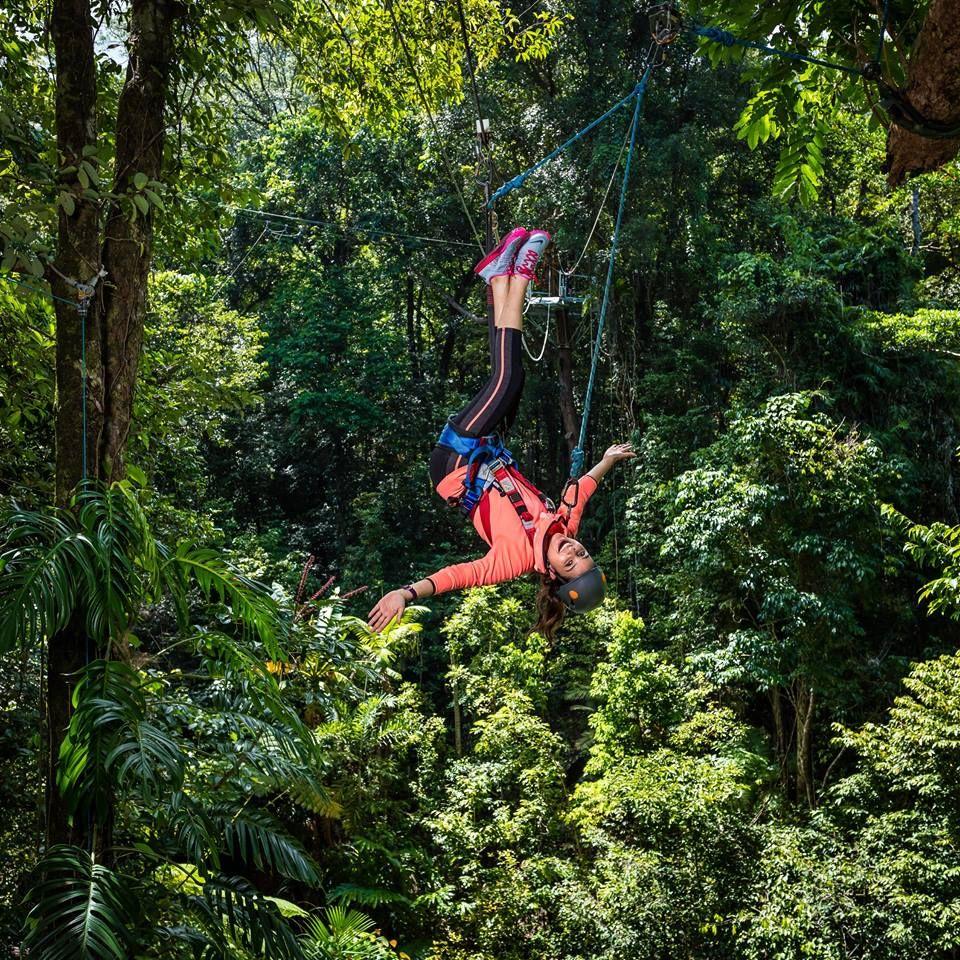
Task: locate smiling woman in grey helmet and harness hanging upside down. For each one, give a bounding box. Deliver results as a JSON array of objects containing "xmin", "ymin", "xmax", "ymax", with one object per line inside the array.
[{"xmin": 369, "ymin": 227, "xmax": 636, "ymax": 639}]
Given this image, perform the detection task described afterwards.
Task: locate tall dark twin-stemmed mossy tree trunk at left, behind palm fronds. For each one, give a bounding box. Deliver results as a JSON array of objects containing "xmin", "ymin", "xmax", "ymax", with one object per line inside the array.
[{"xmin": 46, "ymin": 0, "xmax": 183, "ymax": 844}]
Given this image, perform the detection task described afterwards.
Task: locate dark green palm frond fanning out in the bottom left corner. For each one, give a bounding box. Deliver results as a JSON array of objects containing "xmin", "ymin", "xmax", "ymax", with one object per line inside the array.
[{"xmin": 25, "ymin": 845, "xmax": 137, "ymax": 960}]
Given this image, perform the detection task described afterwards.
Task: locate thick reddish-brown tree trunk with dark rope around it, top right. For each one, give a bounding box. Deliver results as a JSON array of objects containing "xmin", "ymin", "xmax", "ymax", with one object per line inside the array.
[{"xmin": 886, "ymin": 0, "xmax": 960, "ymax": 186}]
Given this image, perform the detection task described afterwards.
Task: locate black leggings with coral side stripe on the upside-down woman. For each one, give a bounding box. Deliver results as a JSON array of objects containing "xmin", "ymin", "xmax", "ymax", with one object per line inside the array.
[{"xmin": 430, "ymin": 319, "xmax": 524, "ymax": 487}]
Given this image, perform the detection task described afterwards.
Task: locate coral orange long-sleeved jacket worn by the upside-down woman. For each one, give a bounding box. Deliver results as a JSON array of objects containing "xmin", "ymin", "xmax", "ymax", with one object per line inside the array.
[{"xmin": 427, "ymin": 466, "xmax": 597, "ymax": 593}]
